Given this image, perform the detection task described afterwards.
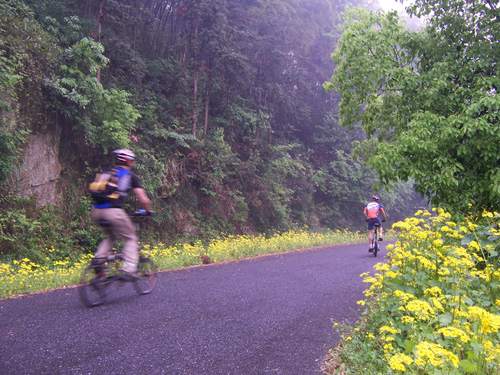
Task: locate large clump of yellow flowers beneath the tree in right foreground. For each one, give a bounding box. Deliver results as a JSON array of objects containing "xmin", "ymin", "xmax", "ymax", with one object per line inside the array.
[{"xmin": 325, "ymin": 210, "xmax": 500, "ymax": 375}]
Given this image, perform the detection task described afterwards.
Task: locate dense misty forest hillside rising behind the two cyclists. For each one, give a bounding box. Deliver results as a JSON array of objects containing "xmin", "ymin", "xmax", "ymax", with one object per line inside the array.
[{"xmin": 0, "ymin": 0, "xmax": 422, "ymax": 261}]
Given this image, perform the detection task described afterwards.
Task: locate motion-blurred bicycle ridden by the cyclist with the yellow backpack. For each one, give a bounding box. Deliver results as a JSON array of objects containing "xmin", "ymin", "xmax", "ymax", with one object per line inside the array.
[{"xmin": 78, "ymin": 210, "xmax": 157, "ymax": 307}]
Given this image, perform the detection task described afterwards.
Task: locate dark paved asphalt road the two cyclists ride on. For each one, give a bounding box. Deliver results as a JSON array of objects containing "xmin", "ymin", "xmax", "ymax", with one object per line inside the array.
[{"xmin": 0, "ymin": 244, "xmax": 385, "ymax": 375}]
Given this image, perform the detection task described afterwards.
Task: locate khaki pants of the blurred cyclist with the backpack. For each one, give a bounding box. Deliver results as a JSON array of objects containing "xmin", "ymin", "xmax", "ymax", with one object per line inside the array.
[{"xmin": 90, "ymin": 208, "xmax": 139, "ymax": 272}]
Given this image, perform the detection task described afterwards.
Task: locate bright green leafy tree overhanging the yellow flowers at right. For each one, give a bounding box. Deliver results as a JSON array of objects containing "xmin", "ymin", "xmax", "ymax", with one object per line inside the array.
[{"xmin": 326, "ymin": 0, "xmax": 500, "ymax": 213}]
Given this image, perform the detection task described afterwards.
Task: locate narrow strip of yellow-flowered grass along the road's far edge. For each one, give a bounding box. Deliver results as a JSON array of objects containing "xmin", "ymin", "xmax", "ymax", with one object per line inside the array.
[{"xmin": 0, "ymin": 228, "xmax": 367, "ymax": 298}]
